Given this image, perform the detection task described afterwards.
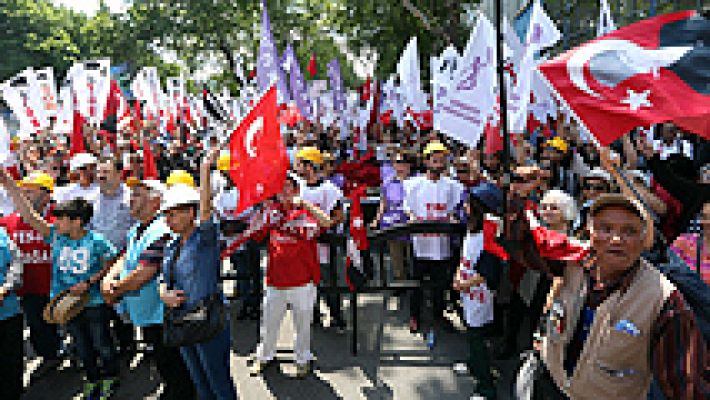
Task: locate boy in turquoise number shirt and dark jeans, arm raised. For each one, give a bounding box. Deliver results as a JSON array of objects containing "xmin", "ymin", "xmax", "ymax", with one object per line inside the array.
[{"xmin": 0, "ymin": 170, "xmax": 118, "ymax": 399}]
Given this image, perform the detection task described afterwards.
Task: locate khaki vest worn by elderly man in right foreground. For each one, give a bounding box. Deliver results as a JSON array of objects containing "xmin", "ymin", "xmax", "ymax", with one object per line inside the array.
[{"xmin": 541, "ymin": 260, "xmax": 675, "ymax": 400}]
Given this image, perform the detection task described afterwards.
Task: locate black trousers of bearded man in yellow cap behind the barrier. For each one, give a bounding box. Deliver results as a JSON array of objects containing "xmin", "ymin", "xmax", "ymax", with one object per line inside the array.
[{"xmin": 409, "ymin": 258, "xmax": 453, "ymax": 321}]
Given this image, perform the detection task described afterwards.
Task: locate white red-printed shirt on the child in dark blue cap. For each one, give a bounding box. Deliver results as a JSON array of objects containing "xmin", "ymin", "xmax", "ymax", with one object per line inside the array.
[{"xmin": 459, "ymin": 232, "xmax": 493, "ymax": 328}]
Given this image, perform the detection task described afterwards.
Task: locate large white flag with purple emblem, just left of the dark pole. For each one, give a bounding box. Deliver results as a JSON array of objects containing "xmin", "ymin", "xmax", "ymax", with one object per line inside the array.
[{"xmin": 434, "ymin": 14, "xmax": 496, "ymax": 147}]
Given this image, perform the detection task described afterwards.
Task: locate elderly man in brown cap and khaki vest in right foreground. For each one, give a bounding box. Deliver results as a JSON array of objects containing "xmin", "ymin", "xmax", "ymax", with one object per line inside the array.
[{"xmin": 511, "ymin": 188, "xmax": 709, "ymax": 400}]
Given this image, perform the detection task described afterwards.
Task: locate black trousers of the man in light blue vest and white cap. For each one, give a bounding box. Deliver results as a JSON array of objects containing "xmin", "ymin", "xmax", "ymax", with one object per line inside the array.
[{"xmin": 143, "ymin": 325, "xmax": 196, "ymax": 400}]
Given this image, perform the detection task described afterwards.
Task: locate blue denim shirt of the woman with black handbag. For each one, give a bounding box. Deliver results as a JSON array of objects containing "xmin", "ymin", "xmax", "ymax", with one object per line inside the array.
[{"xmin": 162, "ymin": 221, "xmax": 221, "ymax": 308}]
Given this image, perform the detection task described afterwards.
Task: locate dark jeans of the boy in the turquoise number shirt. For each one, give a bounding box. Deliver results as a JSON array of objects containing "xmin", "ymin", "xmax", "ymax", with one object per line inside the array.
[{"xmin": 67, "ymin": 305, "xmax": 119, "ymax": 382}]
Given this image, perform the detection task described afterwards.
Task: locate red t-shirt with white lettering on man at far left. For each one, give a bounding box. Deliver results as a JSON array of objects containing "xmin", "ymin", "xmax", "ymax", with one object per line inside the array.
[{"xmin": 0, "ymin": 213, "xmax": 54, "ymax": 296}]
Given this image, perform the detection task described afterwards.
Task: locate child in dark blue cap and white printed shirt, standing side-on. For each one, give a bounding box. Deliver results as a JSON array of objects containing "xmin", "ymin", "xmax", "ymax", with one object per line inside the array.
[{"xmin": 454, "ymin": 183, "xmax": 503, "ymax": 399}]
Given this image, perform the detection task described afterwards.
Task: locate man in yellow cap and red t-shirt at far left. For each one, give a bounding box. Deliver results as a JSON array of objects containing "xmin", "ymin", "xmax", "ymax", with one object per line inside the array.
[{"xmin": 0, "ymin": 172, "xmax": 59, "ymax": 375}]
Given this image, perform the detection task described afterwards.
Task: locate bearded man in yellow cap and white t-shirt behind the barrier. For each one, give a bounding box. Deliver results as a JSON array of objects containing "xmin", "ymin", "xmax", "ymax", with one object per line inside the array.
[{"xmin": 404, "ymin": 141, "xmax": 463, "ymax": 333}]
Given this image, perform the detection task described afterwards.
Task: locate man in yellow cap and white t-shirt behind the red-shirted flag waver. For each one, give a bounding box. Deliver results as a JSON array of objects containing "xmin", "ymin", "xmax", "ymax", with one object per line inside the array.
[{"xmin": 296, "ymin": 147, "xmax": 345, "ymax": 332}]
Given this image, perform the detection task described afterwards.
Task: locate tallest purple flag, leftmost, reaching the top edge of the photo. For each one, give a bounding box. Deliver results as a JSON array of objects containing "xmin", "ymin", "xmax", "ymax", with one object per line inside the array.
[{"xmin": 256, "ymin": 0, "xmax": 289, "ymax": 103}]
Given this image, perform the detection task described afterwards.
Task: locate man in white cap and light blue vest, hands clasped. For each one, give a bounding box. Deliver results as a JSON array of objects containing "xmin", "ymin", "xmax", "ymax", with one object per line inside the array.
[{"xmin": 101, "ymin": 179, "xmax": 195, "ymax": 399}]
